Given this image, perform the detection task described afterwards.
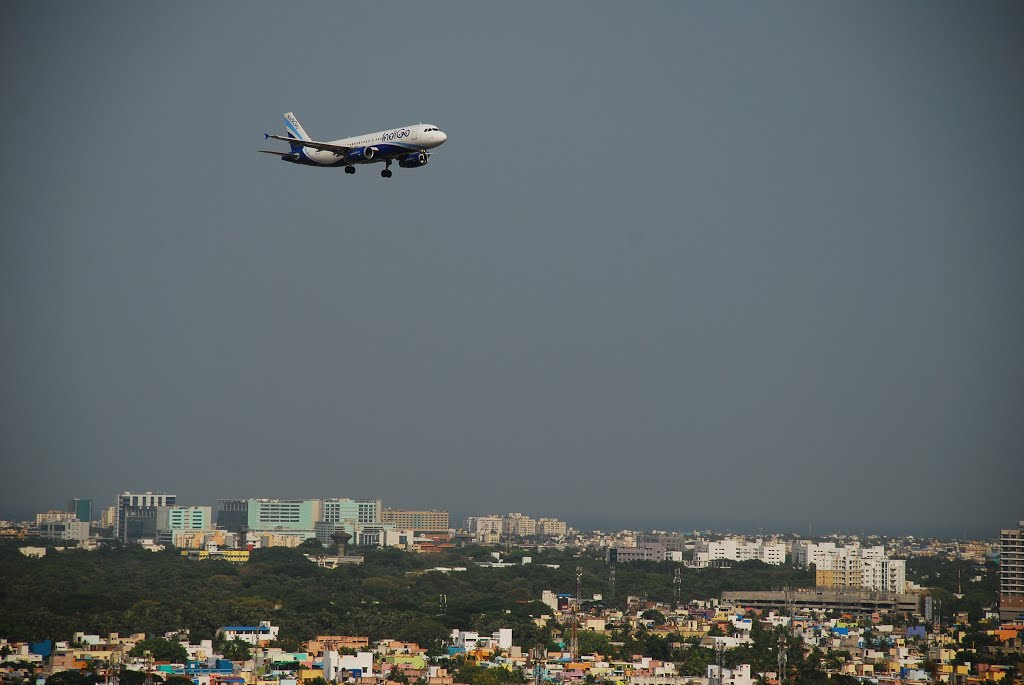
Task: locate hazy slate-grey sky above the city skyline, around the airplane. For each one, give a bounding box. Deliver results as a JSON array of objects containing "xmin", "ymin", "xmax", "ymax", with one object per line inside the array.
[{"xmin": 0, "ymin": 2, "xmax": 1024, "ymax": 534}]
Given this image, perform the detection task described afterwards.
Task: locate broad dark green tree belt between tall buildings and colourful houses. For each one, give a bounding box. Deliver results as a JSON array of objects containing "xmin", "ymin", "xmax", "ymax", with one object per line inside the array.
[{"xmin": 0, "ymin": 542, "xmax": 813, "ymax": 647}]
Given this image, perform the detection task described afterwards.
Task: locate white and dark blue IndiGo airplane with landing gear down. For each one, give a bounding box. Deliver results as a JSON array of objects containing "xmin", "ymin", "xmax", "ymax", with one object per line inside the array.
[{"xmin": 259, "ymin": 112, "xmax": 447, "ymax": 178}]
